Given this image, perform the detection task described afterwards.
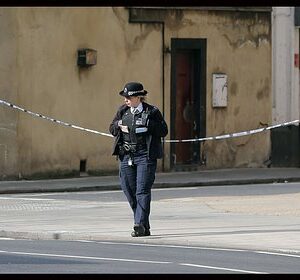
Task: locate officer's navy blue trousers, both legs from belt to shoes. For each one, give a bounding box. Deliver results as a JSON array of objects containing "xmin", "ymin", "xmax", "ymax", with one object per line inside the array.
[{"xmin": 120, "ymin": 151, "xmax": 157, "ymax": 229}]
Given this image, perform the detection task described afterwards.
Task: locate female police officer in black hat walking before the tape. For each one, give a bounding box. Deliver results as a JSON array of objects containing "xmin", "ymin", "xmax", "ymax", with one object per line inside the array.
[{"xmin": 109, "ymin": 82, "xmax": 168, "ymax": 237}]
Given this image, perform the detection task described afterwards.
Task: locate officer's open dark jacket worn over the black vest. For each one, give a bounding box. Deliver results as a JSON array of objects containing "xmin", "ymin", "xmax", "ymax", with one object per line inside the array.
[{"xmin": 109, "ymin": 102, "xmax": 168, "ymax": 159}]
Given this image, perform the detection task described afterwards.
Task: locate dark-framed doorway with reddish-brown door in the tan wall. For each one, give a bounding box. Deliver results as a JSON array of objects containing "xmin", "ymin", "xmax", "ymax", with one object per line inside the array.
[{"xmin": 170, "ymin": 39, "xmax": 206, "ymax": 171}]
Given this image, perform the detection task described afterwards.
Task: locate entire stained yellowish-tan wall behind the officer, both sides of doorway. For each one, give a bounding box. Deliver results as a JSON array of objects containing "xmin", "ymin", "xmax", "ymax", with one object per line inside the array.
[{"xmin": 0, "ymin": 7, "xmax": 272, "ymax": 176}]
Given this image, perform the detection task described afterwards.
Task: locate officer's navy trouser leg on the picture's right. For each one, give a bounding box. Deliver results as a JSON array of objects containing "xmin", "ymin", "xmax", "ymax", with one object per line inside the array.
[{"xmin": 134, "ymin": 155, "xmax": 157, "ymax": 230}]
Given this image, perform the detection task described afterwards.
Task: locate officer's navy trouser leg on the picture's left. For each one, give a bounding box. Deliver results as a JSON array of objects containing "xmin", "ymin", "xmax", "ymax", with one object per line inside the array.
[{"xmin": 119, "ymin": 155, "xmax": 137, "ymax": 215}]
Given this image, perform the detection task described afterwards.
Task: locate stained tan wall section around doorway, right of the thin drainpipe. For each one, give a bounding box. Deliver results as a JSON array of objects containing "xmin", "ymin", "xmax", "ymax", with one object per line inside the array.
[{"xmin": 166, "ymin": 11, "xmax": 272, "ymax": 168}]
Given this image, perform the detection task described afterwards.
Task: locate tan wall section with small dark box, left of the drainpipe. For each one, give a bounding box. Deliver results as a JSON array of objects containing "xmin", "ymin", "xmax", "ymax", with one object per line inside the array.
[{"xmin": 1, "ymin": 8, "xmax": 161, "ymax": 176}]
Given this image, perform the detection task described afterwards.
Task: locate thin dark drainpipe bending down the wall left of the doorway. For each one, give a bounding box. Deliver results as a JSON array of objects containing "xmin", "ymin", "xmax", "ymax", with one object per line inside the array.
[{"xmin": 129, "ymin": 14, "xmax": 165, "ymax": 172}]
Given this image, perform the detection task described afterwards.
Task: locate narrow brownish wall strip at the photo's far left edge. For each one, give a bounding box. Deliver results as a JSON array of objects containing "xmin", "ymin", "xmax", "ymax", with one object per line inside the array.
[{"xmin": 0, "ymin": 9, "xmax": 18, "ymax": 179}]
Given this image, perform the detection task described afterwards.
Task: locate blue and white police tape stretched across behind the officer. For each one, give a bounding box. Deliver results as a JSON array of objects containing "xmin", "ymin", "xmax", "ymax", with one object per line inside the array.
[{"xmin": 0, "ymin": 99, "xmax": 300, "ymax": 143}]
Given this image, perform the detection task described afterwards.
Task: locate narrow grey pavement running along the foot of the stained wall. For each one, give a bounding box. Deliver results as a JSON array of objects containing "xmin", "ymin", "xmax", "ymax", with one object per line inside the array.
[{"xmin": 0, "ymin": 168, "xmax": 300, "ymax": 194}]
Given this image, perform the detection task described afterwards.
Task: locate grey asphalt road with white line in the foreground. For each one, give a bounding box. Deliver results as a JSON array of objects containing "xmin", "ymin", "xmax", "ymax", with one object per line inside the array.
[{"xmin": 0, "ymin": 240, "xmax": 300, "ymax": 274}]
